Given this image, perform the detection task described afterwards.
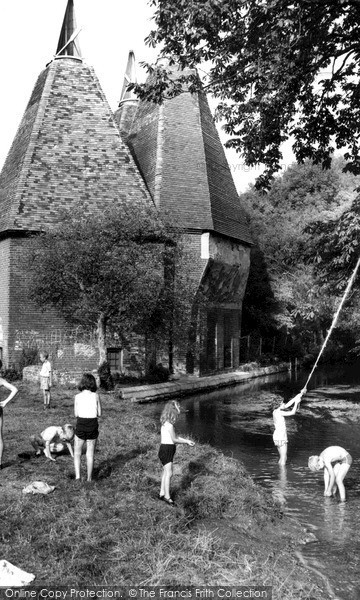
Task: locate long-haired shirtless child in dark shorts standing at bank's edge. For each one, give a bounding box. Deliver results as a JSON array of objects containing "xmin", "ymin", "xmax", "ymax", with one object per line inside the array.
[{"xmin": 159, "ymin": 400, "xmax": 195, "ymax": 506}]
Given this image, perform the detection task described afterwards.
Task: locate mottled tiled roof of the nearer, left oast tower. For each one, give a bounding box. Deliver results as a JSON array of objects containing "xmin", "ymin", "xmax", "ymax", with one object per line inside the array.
[{"xmin": 0, "ymin": 57, "xmax": 152, "ymax": 232}]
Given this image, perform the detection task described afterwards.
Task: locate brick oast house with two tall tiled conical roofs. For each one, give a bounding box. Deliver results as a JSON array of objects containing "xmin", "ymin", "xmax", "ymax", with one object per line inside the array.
[{"xmin": 0, "ymin": 0, "xmax": 251, "ymax": 373}]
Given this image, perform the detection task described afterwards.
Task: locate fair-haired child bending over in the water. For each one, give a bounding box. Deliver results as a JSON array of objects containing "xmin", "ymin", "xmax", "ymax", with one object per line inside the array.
[{"xmin": 308, "ymin": 446, "xmax": 352, "ymax": 502}]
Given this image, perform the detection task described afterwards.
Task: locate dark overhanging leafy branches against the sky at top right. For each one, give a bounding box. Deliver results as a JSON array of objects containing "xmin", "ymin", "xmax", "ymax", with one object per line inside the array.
[{"xmin": 134, "ymin": 0, "xmax": 360, "ymax": 187}]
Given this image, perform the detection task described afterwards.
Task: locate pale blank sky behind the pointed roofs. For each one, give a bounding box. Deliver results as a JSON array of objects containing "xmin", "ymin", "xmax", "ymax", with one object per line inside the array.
[{"xmin": 0, "ymin": 0, "xmax": 291, "ymax": 192}]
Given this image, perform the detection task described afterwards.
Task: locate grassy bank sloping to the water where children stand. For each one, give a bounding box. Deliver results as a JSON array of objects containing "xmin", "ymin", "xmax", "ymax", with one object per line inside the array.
[{"xmin": 0, "ymin": 384, "xmax": 326, "ymax": 600}]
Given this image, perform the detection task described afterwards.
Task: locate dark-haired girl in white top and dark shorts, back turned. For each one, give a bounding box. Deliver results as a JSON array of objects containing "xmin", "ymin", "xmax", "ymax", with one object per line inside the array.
[{"xmin": 74, "ymin": 373, "xmax": 101, "ymax": 481}]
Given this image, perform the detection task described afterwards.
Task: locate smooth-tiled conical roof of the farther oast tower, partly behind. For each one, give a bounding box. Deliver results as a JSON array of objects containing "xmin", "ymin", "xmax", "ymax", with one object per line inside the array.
[{"xmin": 128, "ymin": 65, "xmax": 252, "ymax": 244}]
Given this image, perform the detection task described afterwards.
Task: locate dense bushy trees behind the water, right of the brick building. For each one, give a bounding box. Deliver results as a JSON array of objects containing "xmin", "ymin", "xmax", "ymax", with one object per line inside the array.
[{"xmin": 241, "ymin": 159, "xmax": 360, "ymax": 358}]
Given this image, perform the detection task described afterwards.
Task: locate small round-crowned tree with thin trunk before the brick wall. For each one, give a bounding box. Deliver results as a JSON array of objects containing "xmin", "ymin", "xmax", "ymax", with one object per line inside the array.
[{"xmin": 26, "ymin": 206, "xmax": 184, "ymax": 364}]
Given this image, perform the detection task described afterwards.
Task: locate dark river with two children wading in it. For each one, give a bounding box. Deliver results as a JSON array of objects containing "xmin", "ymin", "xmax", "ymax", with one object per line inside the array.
[{"xmin": 145, "ymin": 368, "xmax": 360, "ymax": 600}]
